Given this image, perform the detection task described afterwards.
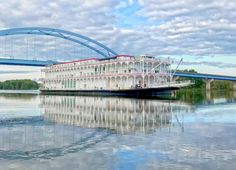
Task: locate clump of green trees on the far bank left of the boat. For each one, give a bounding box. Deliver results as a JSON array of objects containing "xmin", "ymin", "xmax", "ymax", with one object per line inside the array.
[{"xmin": 0, "ymin": 79, "xmax": 39, "ymax": 90}]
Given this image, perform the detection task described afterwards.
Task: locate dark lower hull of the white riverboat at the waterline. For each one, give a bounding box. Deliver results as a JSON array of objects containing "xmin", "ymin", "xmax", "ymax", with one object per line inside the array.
[{"xmin": 40, "ymin": 87, "xmax": 179, "ymax": 97}]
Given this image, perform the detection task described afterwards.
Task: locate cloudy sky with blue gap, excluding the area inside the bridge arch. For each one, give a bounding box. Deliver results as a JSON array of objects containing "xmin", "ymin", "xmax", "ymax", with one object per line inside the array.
[{"xmin": 0, "ymin": 0, "xmax": 236, "ymax": 80}]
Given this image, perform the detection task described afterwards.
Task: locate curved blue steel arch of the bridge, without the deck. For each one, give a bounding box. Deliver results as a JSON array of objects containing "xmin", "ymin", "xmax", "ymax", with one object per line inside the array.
[{"xmin": 0, "ymin": 27, "xmax": 118, "ymax": 58}]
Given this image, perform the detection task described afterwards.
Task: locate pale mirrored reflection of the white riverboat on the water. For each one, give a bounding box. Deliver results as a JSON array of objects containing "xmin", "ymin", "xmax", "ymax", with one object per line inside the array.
[{"xmin": 40, "ymin": 96, "xmax": 192, "ymax": 133}]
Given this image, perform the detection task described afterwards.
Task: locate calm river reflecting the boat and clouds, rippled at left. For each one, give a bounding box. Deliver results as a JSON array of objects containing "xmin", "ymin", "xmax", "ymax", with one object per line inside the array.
[{"xmin": 0, "ymin": 92, "xmax": 236, "ymax": 170}]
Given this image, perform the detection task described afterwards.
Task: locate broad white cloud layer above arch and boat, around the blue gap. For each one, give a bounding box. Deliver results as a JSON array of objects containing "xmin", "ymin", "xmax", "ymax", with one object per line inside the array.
[{"xmin": 0, "ymin": 0, "xmax": 236, "ymax": 55}]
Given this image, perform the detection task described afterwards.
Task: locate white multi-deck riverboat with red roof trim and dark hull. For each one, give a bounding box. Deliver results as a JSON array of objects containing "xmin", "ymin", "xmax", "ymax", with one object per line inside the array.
[{"xmin": 40, "ymin": 55, "xmax": 191, "ymax": 97}]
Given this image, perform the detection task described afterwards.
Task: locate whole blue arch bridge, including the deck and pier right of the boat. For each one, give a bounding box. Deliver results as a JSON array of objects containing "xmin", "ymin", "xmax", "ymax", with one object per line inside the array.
[{"xmin": 0, "ymin": 27, "xmax": 236, "ymax": 90}]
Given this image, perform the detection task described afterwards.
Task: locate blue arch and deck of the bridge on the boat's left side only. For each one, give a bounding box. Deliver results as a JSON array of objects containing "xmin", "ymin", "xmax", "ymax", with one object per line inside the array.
[{"xmin": 0, "ymin": 27, "xmax": 118, "ymax": 67}]
